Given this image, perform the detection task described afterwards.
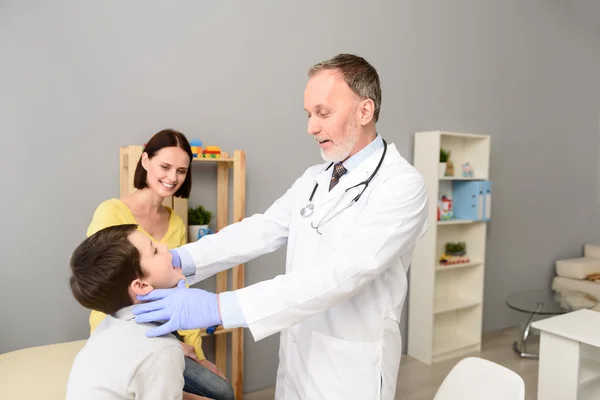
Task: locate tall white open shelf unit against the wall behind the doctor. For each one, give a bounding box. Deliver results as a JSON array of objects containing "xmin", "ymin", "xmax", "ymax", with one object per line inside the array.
[{"xmin": 408, "ymin": 131, "xmax": 490, "ymax": 365}]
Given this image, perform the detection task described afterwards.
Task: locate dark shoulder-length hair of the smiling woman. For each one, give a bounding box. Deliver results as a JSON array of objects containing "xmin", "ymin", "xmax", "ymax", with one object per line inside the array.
[{"xmin": 133, "ymin": 129, "xmax": 194, "ymax": 199}]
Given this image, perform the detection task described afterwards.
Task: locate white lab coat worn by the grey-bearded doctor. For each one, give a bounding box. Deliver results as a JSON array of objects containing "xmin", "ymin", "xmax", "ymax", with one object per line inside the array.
[{"xmin": 180, "ymin": 144, "xmax": 427, "ymax": 400}]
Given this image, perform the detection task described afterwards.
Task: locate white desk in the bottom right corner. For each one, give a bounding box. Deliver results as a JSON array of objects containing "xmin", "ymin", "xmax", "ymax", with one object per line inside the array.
[{"xmin": 532, "ymin": 310, "xmax": 600, "ymax": 400}]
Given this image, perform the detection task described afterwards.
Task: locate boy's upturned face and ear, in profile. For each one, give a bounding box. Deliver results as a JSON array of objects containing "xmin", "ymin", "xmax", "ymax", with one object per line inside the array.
[{"xmin": 129, "ymin": 230, "xmax": 185, "ymax": 295}]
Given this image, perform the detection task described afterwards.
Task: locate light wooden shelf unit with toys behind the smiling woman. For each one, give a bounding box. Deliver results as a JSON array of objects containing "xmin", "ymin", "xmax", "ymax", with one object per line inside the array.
[{"xmin": 119, "ymin": 145, "xmax": 246, "ymax": 400}]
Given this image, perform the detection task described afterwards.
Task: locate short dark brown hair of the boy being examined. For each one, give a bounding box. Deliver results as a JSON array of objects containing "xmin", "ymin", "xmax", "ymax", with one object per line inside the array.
[{"xmin": 69, "ymin": 224, "xmax": 145, "ymax": 314}]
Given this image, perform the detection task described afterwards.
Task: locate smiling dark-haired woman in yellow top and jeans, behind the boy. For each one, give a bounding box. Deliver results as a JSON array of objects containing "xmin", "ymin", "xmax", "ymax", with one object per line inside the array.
[{"xmin": 87, "ymin": 129, "xmax": 233, "ymax": 400}]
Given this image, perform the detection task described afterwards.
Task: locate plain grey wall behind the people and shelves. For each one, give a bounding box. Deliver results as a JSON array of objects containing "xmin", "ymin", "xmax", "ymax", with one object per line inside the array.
[{"xmin": 0, "ymin": 0, "xmax": 600, "ymax": 391}]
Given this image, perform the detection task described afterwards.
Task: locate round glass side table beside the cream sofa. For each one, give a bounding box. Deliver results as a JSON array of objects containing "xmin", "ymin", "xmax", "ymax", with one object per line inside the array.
[{"xmin": 506, "ymin": 289, "xmax": 598, "ymax": 359}]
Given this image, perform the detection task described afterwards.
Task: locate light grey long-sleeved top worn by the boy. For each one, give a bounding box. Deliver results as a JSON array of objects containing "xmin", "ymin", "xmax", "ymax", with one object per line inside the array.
[{"xmin": 67, "ymin": 306, "xmax": 185, "ymax": 400}]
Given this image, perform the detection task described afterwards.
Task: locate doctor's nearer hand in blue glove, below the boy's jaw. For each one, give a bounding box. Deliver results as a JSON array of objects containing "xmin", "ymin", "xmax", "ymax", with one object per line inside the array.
[{"xmin": 133, "ymin": 280, "xmax": 222, "ymax": 337}]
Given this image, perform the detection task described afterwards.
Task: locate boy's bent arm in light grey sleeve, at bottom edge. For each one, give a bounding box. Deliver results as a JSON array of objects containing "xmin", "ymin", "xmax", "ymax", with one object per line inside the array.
[{"xmin": 129, "ymin": 343, "xmax": 185, "ymax": 400}]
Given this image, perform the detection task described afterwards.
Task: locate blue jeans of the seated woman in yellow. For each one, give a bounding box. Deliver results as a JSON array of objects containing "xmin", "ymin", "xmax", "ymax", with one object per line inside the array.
[{"xmin": 183, "ymin": 357, "xmax": 234, "ymax": 400}]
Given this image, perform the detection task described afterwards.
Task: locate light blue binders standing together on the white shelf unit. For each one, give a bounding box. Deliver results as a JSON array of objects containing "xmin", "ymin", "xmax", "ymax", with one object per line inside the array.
[{"xmin": 452, "ymin": 181, "xmax": 492, "ymax": 221}]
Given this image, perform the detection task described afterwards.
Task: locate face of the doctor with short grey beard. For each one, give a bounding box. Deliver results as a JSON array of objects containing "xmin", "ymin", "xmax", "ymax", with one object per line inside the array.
[{"xmin": 304, "ymin": 70, "xmax": 360, "ymax": 162}]
